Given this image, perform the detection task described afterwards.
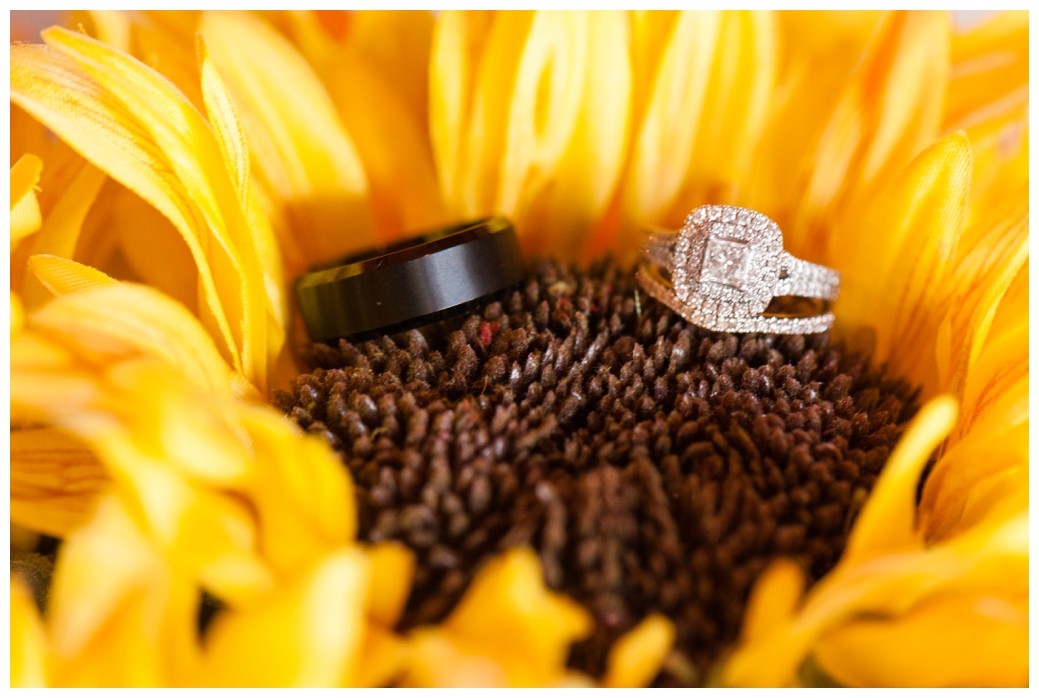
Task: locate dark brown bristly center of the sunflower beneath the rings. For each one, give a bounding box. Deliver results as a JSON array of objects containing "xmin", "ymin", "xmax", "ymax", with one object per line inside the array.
[{"xmin": 277, "ymin": 261, "xmax": 916, "ymax": 684}]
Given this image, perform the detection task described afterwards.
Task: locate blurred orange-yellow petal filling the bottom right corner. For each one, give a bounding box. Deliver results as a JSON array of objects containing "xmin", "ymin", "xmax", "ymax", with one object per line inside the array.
[{"xmin": 815, "ymin": 594, "xmax": 1029, "ymax": 688}]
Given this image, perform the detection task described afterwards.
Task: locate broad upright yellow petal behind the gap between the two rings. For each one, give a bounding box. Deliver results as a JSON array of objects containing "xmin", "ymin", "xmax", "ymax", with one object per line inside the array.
[{"xmin": 511, "ymin": 11, "xmax": 632, "ymax": 258}]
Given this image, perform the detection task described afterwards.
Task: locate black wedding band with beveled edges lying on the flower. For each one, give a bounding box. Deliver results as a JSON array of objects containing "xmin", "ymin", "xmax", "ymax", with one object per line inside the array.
[{"xmin": 296, "ymin": 217, "xmax": 523, "ymax": 342}]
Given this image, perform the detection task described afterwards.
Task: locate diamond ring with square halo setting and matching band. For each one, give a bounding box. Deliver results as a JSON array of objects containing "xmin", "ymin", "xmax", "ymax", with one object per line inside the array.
[{"xmin": 636, "ymin": 206, "xmax": 841, "ymax": 334}]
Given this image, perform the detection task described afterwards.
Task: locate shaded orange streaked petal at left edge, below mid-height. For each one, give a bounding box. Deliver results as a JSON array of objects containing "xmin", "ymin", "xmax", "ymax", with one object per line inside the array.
[{"xmin": 10, "ymin": 428, "xmax": 108, "ymax": 538}]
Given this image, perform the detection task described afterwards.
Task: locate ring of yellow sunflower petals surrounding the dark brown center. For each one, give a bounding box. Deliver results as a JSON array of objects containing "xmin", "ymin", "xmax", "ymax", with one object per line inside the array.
[{"xmin": 10, "ymin": 11, "xmax": 1029, "ymax": 686}]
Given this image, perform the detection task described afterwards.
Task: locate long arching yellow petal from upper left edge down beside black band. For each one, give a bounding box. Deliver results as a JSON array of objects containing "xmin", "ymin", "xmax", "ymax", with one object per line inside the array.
[{"xmin": 11, "ymin": 28, "xmax": 279, "ymax": 387}]
